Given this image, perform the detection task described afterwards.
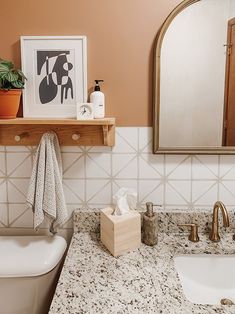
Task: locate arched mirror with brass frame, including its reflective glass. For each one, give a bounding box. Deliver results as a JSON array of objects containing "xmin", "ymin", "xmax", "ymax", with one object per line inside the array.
[{"xmin": 154, "ymin": 0, "xmax": 235, "ymax": 154}]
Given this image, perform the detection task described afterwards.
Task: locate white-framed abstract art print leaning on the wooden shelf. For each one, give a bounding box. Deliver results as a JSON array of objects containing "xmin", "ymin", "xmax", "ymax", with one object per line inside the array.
[{"xmin": 20, "ymin": 36, "xmax": 87, "ymax": 118}]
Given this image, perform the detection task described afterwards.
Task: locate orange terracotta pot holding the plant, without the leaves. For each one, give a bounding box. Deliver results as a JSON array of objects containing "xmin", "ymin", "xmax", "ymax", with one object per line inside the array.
[{"xmin": 0, "ymin": 89, "xmax": 22, "ymax": 119}]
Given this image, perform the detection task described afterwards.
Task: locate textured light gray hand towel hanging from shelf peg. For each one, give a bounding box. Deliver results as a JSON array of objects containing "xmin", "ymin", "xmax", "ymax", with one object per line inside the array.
[{"xmin": 26, "ymin": 132, "xmax": 68, "ymax": 233}]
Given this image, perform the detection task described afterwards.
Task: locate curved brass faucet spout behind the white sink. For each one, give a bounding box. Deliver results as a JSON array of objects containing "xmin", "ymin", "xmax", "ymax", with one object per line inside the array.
[{"xmin": 209, "ymin": 201, "xmax": 229, "ymax": 242}]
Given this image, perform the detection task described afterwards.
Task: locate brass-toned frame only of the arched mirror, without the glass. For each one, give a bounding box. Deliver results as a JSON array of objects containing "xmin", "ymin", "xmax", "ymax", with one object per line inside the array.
[{"xmin": 153, "ymin": 0, "xmax": 235, "ymax": 155}]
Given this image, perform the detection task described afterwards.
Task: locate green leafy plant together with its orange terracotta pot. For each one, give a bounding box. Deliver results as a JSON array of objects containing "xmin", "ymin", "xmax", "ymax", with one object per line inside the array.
[{"xmin": 0, "ymin": 58, "xmax": 26, "ymax": 119}]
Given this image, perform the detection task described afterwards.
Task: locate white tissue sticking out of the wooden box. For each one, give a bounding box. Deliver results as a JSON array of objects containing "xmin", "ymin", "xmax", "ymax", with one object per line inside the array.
[{"xmin": 113, "ymin": 188, "xmax": 137, "ymax": 216}]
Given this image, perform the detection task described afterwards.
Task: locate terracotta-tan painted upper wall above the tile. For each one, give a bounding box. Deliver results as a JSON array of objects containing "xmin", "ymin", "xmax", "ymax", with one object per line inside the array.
[{"xmin": 0, "ymin": 0, "xmax": 181, "ymax": 126}]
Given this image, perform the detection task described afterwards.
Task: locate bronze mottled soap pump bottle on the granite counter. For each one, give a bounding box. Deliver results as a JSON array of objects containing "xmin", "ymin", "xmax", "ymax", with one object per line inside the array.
[{"xmin": 142, "ymin": 202, "xmax": 161, "ymax": 246}]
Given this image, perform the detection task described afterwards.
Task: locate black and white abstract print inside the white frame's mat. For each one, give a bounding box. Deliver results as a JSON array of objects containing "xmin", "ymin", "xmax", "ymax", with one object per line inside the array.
[{"xmin": 36, "ymin": 50, "xmax": 75, "ymax": 105}]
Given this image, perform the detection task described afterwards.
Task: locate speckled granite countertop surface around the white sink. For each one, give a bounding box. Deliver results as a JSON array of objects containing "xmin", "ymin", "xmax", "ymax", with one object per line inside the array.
[{"xmin": 49, "ymin": 233, "xmax": 235, "ymax": 314}]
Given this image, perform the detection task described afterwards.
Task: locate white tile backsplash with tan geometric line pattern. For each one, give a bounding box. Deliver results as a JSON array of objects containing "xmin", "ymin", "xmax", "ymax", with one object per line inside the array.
[{"xmin": 0, "ymin": 127, "xmax": 235, "ymax": 229}]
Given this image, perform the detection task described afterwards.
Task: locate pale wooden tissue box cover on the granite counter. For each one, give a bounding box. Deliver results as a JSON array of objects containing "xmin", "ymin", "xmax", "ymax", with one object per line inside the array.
[{"xmin": 100, "ymin": 207, "xmax": 141, "ymax": 256}]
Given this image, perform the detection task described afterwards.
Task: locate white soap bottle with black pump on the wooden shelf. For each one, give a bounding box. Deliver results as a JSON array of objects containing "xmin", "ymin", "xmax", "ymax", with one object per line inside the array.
[{"xmin": 90, "ymin": 80, "xmax": 105, "ymax": 119}]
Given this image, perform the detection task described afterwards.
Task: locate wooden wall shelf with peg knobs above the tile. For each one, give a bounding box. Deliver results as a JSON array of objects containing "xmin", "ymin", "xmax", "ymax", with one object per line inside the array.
[{"xmin": 0, "ymin": 118, "xmax": 115, "ymax": 146}]
